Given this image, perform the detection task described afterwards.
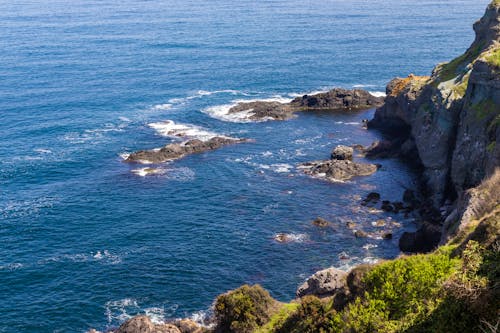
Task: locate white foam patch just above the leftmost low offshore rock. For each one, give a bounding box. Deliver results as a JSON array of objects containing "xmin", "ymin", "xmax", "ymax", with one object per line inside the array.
[{"xmin": 148, "ymin": 120, "xmax": 226, "ymax": 141}]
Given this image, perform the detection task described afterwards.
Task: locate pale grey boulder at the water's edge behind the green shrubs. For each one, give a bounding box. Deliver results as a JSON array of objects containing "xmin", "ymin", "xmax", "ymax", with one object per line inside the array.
[{"xmin": 296, "ymin": 267, "xmax": 347, "ymax": 298}]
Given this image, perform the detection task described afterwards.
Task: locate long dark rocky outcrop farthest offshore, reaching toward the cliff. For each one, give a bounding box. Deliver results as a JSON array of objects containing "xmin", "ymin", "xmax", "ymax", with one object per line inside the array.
[{"xmin": 229, "ymin": 88, "xmax": 383, "ymax": 120}]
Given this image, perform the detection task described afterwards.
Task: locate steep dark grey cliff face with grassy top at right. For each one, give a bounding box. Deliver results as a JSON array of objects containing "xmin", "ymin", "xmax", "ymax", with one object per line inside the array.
[{"xmin": 369, "ymin": 0, "xmax": 500, "ymax": 239}]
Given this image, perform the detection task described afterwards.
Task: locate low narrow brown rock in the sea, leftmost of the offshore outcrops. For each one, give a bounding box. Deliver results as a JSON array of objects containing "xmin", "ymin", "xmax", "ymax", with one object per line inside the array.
[{"xmin": 125, "ymin": 136, "xmax": 246, "ymax": 163}]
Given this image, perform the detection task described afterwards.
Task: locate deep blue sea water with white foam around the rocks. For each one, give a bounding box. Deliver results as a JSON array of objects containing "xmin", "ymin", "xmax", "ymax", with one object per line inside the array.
[{"xmin": 0, "ymin": 0, "xmax": 489, "ymax": 332}]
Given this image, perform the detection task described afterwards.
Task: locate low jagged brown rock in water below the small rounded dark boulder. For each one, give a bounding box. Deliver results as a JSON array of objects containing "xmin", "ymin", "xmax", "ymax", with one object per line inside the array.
[{"xmin": 301, "ymin": 160, "xmax": 377, "ymax": 181}]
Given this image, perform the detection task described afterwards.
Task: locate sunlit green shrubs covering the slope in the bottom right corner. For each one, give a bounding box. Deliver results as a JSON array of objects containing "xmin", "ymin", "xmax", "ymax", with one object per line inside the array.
[{"xmin": 215, "ymin": 204, "xmax": 500, "ymax": 333}]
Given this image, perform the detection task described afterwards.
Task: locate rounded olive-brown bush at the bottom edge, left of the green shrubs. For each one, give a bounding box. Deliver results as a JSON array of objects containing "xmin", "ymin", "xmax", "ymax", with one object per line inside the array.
[{"xmin": 215, "ymin": 285, "xmax": 276, "ymax": 333}]
